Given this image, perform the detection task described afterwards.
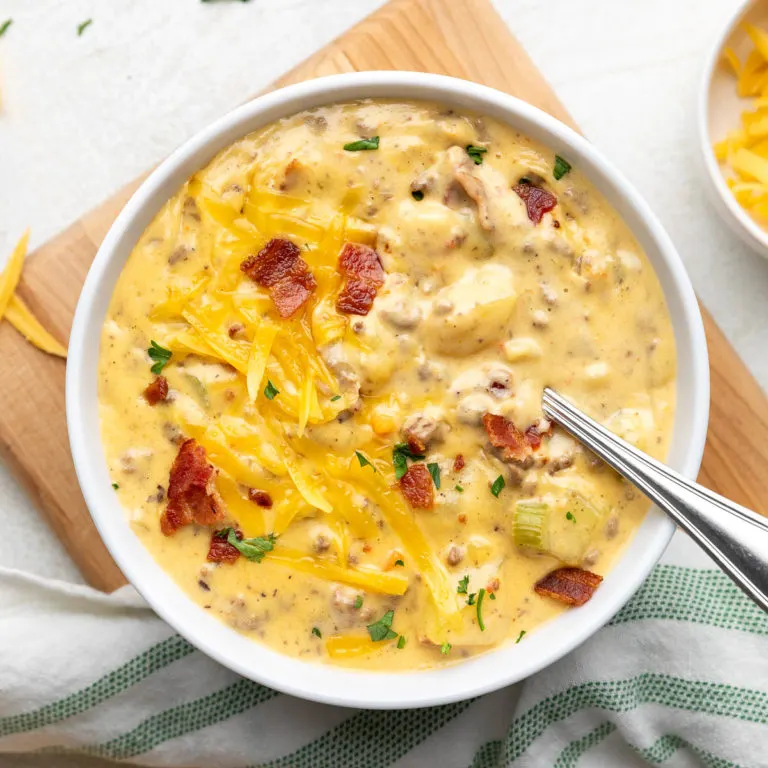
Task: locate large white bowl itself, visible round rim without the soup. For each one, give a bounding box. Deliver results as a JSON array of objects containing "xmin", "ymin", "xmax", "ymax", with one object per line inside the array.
[{"xmin": 67, "ymin": 72, "xmax": 709, "ymax": 709}]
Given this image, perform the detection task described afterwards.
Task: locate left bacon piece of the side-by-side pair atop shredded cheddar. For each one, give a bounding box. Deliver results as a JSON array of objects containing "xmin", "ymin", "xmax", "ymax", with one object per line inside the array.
[{"xmin": 240, "ymin": 238, "xmax": 317, "ymax": 317}]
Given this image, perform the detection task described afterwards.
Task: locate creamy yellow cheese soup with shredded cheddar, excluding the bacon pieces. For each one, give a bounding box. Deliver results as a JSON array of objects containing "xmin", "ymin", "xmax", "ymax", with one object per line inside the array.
[{"xmin": 99, "ymin": 101, "xmax": 675, "ymax": 669}]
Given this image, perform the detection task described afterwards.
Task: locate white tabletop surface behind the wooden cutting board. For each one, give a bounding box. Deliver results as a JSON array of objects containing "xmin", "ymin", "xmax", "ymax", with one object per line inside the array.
[{"xmin": 0, "ymin": 0, "xmax": 768, "ymax": 580}]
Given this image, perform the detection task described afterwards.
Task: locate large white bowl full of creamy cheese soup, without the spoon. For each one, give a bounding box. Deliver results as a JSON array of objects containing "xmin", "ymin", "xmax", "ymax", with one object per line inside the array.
[{"xmin": 67, "ymin": 72, "xmax": 708, "ymax": 708}]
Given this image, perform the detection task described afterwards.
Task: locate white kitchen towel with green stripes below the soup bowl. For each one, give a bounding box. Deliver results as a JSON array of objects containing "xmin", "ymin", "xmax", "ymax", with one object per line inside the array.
[{"xmin": 0, "ymin": 534, "xmax": 768, "ymax": 768}]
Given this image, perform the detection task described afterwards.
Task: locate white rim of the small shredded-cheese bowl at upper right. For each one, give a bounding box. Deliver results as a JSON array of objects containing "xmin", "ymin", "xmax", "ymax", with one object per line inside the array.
[{"xmin": 697, "ymin": 0, "xmax": 768, "ymax": 258}]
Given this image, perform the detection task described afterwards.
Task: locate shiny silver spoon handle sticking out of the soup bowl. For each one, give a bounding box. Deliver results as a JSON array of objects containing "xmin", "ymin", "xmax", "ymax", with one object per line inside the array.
[{"xmin": 542, "ymin": 388, "xmax": 768, "ymax": 611}]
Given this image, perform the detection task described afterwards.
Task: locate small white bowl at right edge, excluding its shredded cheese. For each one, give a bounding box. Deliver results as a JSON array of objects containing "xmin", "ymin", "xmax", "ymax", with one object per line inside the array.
[{"xmin": 698, "ymin": 0, "xmax": 768, "ymax": 258}]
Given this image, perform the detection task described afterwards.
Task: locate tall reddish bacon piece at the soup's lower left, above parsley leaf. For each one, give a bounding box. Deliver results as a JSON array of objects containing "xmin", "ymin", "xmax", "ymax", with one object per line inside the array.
[{"xmin": 160, "ymin": 440, "xmax": 225, "ymax": 536}]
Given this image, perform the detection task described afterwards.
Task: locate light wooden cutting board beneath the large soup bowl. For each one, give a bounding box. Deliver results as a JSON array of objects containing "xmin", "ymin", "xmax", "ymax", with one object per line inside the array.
[{"xmin": 0, "ymin": 0, "xmax": 768, "ymax": 591}]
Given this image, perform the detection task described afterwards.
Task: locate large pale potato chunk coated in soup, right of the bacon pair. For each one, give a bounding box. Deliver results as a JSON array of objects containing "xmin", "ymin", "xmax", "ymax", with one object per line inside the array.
[{"xmin": 426, "ymin": 264, "xmax": 517, "ymax": 356}]
